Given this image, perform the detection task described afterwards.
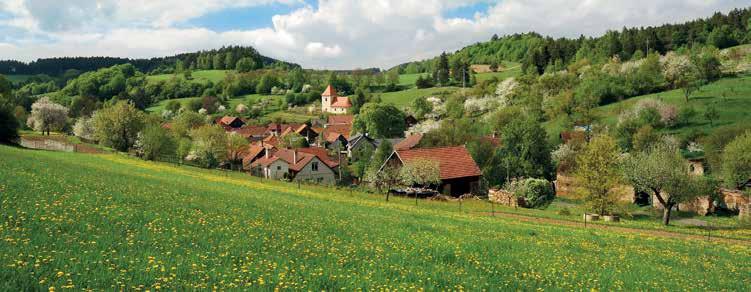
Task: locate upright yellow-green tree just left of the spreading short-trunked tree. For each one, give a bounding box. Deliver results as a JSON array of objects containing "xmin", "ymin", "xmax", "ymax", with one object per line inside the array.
[{"xmin": 575, "ymin": 136, "xmax": 621, "ymax": 215}]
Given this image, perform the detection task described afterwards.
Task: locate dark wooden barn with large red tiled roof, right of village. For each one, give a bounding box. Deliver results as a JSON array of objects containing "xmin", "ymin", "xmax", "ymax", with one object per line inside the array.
[{"xmin": 381, "ymin": 146, "xmax": 482, "ymax": 196}]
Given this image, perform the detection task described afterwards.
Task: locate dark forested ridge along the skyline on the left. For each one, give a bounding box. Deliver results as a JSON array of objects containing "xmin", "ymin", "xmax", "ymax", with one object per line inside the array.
[{"xmin": 0, "ymin": 46, "xmax": 299, "ymax": 76}]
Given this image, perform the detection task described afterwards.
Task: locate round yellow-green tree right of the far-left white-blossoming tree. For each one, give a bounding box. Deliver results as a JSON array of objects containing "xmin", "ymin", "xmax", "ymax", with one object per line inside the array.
[{"xmin": 91, "ymin": 100, "xmax": 145, "ymax": 151}]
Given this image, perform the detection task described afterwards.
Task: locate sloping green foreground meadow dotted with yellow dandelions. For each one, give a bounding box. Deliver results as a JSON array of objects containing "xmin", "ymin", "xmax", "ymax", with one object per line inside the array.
[{"xmin": 0, "ymin": 146, "xmax": 751, "ymax": 291}]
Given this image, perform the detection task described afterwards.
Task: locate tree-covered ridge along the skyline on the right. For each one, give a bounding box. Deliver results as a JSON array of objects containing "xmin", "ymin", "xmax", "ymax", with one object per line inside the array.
[{"xmin": 392, "ymin": 8, "xmax": 751, "ymax": 74}]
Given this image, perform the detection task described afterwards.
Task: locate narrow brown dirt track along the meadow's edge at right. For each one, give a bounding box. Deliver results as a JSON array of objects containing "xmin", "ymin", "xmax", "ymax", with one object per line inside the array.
[{"xmin": 475, "ymin": 211, "xmax": 751, "ymax": 245}]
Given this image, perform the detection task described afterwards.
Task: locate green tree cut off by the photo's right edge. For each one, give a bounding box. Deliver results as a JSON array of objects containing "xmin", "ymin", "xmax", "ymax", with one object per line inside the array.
[{"xmin": 722, "ymin": 131, "xmax": 751, "ymax": 188}]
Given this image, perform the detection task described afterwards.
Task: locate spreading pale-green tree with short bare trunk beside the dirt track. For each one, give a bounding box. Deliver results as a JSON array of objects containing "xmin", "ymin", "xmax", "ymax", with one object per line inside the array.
[{"xmin": 623, "ymin": 143, "xmax": 706, "ymax": 225}]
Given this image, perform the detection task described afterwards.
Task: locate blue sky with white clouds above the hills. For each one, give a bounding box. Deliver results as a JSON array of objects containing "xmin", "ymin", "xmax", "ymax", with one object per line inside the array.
[{"xmin": 0, "ymin": 0, "xmax": 751, "ymax": 69}]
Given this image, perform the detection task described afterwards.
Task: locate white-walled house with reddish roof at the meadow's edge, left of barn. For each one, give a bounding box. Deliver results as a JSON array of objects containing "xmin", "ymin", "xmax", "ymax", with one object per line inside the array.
[{"xmin": 250, "ymin": 149, "xmax": 338, "ymax": 184}]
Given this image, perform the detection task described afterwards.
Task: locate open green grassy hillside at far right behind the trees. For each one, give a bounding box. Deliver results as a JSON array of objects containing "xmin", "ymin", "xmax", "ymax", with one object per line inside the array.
[{"xmin": 546, "ymin": 75, "xmax": 751, "ymax": 140}]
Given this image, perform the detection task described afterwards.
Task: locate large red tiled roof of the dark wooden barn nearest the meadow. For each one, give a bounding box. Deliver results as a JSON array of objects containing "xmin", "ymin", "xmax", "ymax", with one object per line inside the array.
[{"xmin": 396, "ymin": 146, "xmax": 482, "ymax": 180}]
